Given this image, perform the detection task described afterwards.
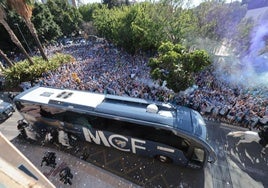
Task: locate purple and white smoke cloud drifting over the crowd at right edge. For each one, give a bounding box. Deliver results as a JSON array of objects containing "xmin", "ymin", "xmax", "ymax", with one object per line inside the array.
[{"xmin": 215, "ymin": 21, "xmax": 268, "ymax": 88}]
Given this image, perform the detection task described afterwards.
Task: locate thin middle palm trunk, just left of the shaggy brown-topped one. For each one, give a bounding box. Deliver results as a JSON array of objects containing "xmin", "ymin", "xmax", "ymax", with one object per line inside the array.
[{"xmin": 0, "ymin": 5, "xmax": 34, "ymax": 65}]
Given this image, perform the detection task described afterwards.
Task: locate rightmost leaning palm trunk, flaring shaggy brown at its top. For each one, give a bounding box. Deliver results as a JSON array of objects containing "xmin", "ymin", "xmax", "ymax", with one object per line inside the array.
[{"xmin": 7, "ymin": 0, "xmax": 48, "ymax": 61}]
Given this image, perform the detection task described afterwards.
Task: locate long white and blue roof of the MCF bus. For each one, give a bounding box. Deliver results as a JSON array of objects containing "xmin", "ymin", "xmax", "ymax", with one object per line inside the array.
[{"xmin": 15, "ymin": 86, "xmax": 194, "ymax": 133}]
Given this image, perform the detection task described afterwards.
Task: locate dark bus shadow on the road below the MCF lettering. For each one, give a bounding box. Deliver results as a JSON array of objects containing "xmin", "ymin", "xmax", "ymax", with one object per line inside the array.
[{"xmin": 13, "ymin": 137, "xmax": 204, "ymax": 188}]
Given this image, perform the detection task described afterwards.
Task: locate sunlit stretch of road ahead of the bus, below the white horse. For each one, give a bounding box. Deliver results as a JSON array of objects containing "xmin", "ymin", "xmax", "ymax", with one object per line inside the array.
[{"xmin": 204, "ymin": 122, "xmax": 268, "ymax": 188}]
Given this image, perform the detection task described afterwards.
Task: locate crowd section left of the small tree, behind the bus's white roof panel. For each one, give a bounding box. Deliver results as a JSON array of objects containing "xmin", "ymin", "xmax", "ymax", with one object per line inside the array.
[{"xmin": 40, "ymin": 39, "xmax": 174, "ymax": 101}]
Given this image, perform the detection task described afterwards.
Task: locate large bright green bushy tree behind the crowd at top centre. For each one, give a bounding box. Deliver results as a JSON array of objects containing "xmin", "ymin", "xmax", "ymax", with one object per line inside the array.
[{"xmin": 93, "ymin": 2, "xmax": 168, "ymax": 53}]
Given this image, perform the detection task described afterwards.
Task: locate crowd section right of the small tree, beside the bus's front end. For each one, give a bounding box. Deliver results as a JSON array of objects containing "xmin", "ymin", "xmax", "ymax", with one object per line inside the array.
[{"xmin": 178, "ymin": 67, "xmax": 268, "ymax": 128}]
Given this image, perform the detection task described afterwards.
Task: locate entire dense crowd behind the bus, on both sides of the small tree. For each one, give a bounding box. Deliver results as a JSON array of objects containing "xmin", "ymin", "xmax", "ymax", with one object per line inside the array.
[{"xmin": 36, "ymin": 41, "xmax": 268, "ymax": 128}]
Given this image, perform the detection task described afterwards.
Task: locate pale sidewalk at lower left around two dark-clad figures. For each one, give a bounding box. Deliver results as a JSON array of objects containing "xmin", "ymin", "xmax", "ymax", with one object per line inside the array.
[{"xmin": 13, "ymin": 138, "xmax": 138, "ymax": 188}]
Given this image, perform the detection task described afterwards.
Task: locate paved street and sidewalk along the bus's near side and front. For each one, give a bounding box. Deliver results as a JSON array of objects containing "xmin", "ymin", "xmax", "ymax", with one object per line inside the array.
[{"xmin": 0, "ymin": 106, "xmax": 268, "ymax": 188}]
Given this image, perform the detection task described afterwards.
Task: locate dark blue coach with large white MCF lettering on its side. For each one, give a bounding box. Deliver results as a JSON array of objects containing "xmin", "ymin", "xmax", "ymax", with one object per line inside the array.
[{"xmin": 14, "ymin": 86, "xmax": 216, "ymax": 168}]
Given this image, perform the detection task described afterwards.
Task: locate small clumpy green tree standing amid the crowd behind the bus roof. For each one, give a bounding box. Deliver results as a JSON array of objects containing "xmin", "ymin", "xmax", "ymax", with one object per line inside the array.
[{"xmin": 149, "ymin": 42, "xmax": 210, "ymax": 92}]
